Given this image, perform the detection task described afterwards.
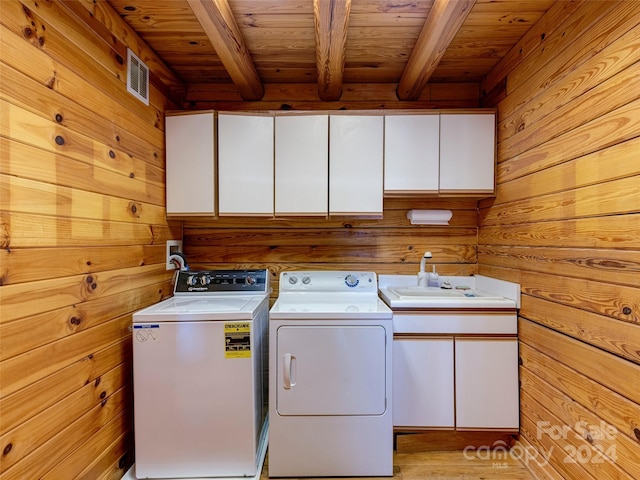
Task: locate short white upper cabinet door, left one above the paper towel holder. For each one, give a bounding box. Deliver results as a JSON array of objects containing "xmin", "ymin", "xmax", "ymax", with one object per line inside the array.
[{"xmin": 384, "ymin": 114, "xmax": 440, "ymax": 195}]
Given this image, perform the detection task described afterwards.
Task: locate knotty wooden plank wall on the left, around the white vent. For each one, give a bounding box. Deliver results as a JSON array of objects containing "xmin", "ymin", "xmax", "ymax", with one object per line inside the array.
[{"xmin": 0, "ymin": 0, "xmax": 181, "ymax": 480}]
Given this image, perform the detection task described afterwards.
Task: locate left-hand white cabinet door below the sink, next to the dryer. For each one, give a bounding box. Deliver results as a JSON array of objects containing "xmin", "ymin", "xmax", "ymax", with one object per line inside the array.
[{"xmin": 393, "ymin": 337, "xmax": 454, "ymax": 428}]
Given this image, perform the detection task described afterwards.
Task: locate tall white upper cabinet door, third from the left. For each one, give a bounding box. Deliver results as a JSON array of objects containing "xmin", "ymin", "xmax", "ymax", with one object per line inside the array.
[{"xmin": 275, "ymin": 115, "xmax": 329, "ymax": 215}]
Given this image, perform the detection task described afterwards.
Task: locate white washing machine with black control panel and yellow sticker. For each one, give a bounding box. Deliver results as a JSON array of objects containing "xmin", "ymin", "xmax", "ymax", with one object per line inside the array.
[{"xmin": 133, "ymin": 270, "xmax": 270, "ymax": 479}]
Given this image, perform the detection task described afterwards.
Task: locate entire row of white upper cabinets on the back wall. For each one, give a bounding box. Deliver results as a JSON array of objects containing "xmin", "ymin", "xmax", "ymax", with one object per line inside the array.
[{"xmin": 166, "ymin": 110, "xmax": 496, "ymax": 217}]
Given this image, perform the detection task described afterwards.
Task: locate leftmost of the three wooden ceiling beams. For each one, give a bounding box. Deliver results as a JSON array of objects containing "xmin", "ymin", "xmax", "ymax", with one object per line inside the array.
[{"xmin": 187, "ymin": 0, "xmax": 264, "ymax": 101}]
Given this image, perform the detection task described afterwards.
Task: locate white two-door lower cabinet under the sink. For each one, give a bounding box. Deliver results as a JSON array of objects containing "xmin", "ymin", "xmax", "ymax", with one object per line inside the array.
[{"xmin": 393, "ymin": 311, "xmax": 520, "ymax": 431}]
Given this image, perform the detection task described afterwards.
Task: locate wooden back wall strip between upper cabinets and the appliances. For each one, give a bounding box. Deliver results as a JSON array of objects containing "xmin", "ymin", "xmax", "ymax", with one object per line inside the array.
[{"xmin": 184, "ymin": 199, "xmax": 477, "ymax": 298}]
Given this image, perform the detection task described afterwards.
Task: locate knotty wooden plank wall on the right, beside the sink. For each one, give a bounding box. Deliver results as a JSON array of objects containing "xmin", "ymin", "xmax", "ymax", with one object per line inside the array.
[{"xmin": 478, "ymin": 1, "xmax": 640, "ymax": 480}]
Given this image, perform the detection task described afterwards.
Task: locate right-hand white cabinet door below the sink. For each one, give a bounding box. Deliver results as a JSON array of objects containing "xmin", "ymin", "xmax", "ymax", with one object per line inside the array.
[{"xmin": 455, "ymin": 338, "xmax": 520, "ymax": 430}]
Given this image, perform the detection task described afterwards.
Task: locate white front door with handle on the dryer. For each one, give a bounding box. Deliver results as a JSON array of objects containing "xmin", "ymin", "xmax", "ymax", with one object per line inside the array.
[{"xmin": 275, "ymin": 325, "xmax": 390, "ymax": 415}]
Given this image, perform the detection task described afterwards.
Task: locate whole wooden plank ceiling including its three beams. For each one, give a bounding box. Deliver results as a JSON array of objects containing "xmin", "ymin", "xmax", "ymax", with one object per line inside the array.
[{"xmin": 108, "ymin": 0, "xmax": 556, "ymax": 101}]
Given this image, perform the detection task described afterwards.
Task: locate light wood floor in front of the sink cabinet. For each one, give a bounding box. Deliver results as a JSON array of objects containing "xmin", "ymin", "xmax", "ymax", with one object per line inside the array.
[{"xmin": 260, "ymin": 451, "xmax": 536, "ymax": 480}]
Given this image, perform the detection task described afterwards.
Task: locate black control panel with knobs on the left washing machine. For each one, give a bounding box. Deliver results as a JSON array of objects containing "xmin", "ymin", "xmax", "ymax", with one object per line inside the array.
[{"xmin": 173, "ymin": 269, "xmax": 269, "ymax": 295}]
